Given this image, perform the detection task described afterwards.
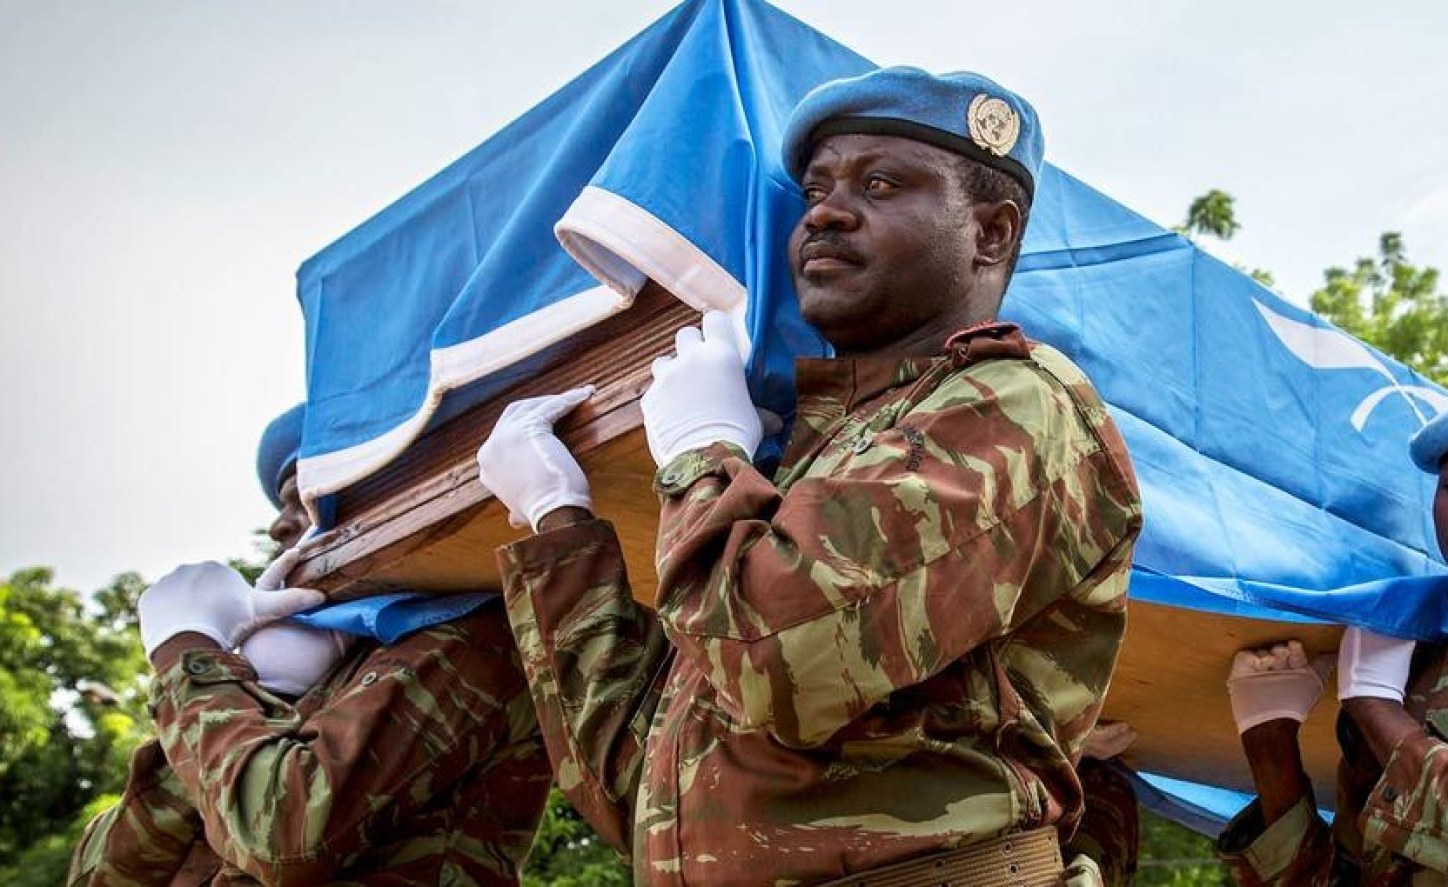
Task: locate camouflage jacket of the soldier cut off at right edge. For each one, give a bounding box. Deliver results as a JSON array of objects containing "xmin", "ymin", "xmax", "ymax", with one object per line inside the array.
[{"xmin": 1218, "ymin": 644, "xmax": 1448, "ymax": 887}]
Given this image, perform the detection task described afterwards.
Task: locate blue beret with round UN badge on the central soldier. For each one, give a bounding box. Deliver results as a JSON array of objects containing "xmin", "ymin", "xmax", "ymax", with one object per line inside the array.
[{"xmin": 783, "ymin": 68, "xmax": 1045, "ymax": 197}]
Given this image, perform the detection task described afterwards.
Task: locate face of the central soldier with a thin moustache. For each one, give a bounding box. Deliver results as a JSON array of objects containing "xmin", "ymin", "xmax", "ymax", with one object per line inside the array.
[{"xmin": 789, "ymin": 135, "xmax": 977, "ymax": 353}]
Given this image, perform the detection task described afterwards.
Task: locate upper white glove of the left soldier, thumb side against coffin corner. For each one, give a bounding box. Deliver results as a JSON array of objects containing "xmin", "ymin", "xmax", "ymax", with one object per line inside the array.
[{"xmin": 136, "ymin": 561, "xmax": 326, "ymax": 657}]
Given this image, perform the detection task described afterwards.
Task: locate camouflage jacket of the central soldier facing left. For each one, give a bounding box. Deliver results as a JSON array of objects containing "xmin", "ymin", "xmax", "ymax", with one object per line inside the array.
[{"xmin": 500, "ymin": 324, "xmax": 1141, "ymax": 884}]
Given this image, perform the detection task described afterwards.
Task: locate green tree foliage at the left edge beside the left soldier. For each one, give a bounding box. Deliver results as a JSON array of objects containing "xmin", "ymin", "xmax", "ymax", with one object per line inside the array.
[{"xmin": 0, "ymin": 569, "xmax": 149, "ymax": 868}]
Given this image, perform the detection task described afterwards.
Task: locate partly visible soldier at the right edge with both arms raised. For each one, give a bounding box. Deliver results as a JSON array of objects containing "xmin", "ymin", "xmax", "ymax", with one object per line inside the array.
[{"xmin": 1218, "ymin": 414, "xmax": 1448, "ymax": 886}]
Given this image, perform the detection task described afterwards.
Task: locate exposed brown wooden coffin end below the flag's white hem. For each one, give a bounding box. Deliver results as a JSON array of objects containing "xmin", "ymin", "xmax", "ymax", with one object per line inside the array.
[{"xmin": 288, "ymin": 282, "xmax": 698, "ymax": 600}]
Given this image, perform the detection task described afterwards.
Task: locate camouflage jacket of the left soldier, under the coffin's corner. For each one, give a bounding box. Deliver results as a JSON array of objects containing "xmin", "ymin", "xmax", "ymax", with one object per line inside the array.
[{"xmin": 70, "ymin": 605, "xmax": 550, "ymax": 887}]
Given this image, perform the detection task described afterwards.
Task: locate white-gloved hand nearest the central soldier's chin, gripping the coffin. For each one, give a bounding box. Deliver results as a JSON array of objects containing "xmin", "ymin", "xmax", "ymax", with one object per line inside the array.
[{"xmin": 640, "ymin": 311, "xmax": 763, "ymax": 466}]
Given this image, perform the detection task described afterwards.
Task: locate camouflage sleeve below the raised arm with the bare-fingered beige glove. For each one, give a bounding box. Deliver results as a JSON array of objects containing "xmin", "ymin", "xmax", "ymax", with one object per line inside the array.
[{"xmin": 1216, "ymin": 797, "xmax": 1337, "ymax": 887}]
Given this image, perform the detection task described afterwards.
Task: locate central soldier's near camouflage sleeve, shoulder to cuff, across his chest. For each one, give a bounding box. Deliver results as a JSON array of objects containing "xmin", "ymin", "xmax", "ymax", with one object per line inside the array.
[{"xmin": 657, "ymin": 360, "xmax": 1140, "ymax": 748}]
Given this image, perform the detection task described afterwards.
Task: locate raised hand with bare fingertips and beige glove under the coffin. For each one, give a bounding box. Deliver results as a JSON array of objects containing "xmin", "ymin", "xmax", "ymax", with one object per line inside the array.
[{"xmin": 1226, "ymin": 641, "xmax": 1332, "ymax": 734}]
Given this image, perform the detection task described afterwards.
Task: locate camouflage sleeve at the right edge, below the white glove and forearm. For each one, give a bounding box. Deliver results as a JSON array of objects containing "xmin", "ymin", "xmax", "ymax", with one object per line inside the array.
[{"xmin": 1358, "ymin": 731, "xmax": 1448, "ymax": 873}]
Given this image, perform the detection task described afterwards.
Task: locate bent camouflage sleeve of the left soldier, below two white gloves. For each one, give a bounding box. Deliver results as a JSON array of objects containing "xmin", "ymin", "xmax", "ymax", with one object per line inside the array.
[{"xmin": 152, "ymin": 606, "xmax": 531, "ymax": 884}]
